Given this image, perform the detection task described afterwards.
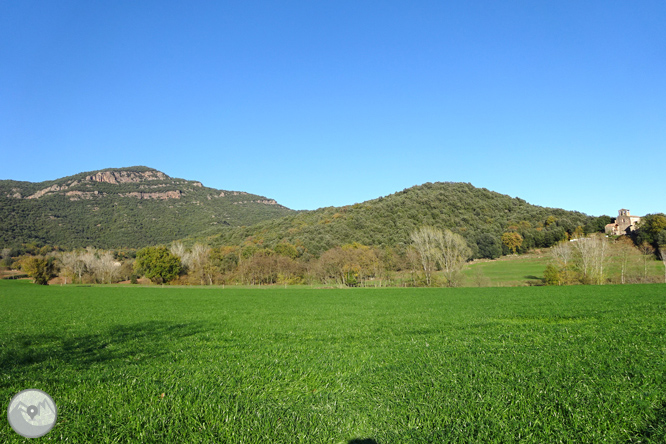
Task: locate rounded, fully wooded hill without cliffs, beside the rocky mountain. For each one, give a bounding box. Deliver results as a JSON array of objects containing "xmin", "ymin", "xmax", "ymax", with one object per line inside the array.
[{"xmin": 199, "ymin": 182, "xmax": 596, "ymax": 257}]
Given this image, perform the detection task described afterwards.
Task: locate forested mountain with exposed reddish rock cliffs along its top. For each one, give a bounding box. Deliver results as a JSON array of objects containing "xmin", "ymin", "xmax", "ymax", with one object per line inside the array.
[{"xmin": 0, "ymin": 166, "xmax": 294, "ymax": 248}]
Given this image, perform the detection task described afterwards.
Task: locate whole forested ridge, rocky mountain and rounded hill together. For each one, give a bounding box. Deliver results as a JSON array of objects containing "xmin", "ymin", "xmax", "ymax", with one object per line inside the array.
[{"xmin": 0, "ymin": 170, "xmax": 606, "ymax": 257}]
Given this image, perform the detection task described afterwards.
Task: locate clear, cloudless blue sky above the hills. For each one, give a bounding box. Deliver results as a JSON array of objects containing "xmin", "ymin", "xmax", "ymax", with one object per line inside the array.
[{"xmin": 0, "ymin": 0, "xmax": 666, "ymax": 215}]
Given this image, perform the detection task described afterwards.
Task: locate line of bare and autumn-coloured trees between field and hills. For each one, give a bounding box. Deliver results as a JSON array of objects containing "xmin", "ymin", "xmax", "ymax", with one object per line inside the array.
[{"xmin": 6, "ymin": 214, "xmax": 666, "ymax": 286}]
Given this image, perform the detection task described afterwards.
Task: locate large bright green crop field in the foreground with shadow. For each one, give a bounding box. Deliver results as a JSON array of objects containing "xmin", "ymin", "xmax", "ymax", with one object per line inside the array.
[{"xmin": 0, "ymin": 281, "xmax": 666, "ymax": 444}]
